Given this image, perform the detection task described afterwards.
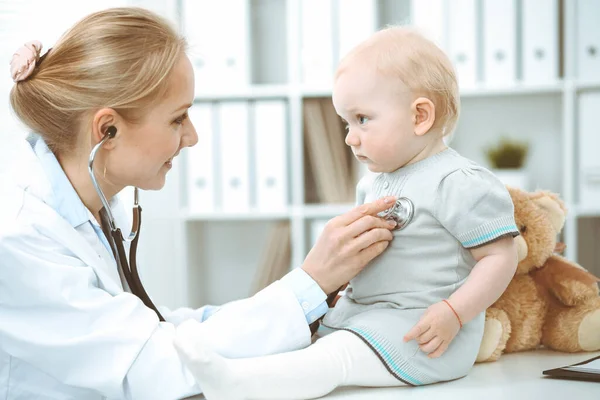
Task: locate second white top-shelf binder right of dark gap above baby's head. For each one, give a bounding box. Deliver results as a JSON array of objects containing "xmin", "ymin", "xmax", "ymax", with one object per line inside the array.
[{"xmin": 448, "ymin": 0, "xmax": 478, "ymax": 88}]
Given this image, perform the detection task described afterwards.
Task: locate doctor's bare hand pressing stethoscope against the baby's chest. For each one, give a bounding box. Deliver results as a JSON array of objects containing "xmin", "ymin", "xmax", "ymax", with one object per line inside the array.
[{"xmin": 302, "ymin": 196, "xmax": 396, "ymax": 294}]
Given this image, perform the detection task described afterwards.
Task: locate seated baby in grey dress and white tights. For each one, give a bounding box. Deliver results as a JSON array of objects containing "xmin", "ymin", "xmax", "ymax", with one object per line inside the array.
[{"xmin": 178, "ymin": 27, "xmax": 519, "ymax": 400}]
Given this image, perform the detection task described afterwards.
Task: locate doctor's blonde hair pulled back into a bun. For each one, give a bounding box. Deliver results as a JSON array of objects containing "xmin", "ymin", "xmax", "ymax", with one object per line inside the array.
[{"xmin": 10, "ymin": 7, "xmax": 186, "ymax": 154}]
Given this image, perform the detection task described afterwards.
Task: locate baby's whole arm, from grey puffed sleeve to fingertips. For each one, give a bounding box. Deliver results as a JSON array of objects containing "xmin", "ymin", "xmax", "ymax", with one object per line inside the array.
[{"xmin": 404, "ymin": 165, "xmax": 519, "ymax": 358}]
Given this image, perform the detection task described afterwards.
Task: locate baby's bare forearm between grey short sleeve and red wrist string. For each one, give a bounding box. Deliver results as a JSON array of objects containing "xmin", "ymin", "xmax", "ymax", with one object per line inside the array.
[{"xmin": 448, "ymin": 236, "xmax": 518, "ymax": 324}]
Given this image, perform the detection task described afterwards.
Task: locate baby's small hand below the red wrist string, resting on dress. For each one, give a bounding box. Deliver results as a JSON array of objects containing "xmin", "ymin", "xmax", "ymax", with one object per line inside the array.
[{"xmin": 404, "ymin": 301, "xmax": 460, "ymax": 358}]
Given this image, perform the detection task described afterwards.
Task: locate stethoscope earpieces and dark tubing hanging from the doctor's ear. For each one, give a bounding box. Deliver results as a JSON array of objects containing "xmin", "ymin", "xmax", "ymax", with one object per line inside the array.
[{"xmin": 88, "ymin": 126, "xmax": 165, "ymax": 321}]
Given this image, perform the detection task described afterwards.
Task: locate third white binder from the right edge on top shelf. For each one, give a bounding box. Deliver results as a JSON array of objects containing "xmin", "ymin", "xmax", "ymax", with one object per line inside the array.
[{"xmin": 481, "ymin": 0, "xmax": 517, "ymax": 85}]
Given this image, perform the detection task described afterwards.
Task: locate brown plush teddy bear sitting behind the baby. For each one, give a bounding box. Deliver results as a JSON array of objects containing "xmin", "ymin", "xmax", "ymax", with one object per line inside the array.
[{"xmin": 477, "ymin": 187, "xmax": 600, "ymax": 362}]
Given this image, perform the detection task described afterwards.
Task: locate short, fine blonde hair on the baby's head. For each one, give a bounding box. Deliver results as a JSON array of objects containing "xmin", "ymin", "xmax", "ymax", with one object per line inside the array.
[{"xmin": 336, "ymin": 26, "xmax": 460, "ymax": 136}]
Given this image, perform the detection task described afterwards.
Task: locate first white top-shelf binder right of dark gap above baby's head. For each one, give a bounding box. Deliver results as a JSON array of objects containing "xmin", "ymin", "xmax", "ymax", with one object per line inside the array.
[{"xmin": 410, "ymin": 0, "xmax": 448, "ymax": 51}]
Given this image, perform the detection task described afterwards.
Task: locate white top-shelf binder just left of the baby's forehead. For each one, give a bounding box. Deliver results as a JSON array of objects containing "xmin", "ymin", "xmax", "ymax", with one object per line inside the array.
[{"xmin": 300, "ymin": 0, "xmax": 334, "ymax": 86}]
